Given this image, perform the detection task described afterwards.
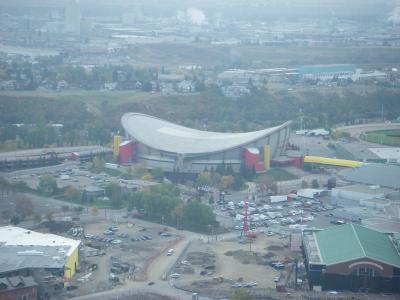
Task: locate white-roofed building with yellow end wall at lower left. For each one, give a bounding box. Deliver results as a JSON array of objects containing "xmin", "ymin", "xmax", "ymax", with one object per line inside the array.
[{"xmin": 0, "ymin": 226, "xmax": 81, "ymax": 284}]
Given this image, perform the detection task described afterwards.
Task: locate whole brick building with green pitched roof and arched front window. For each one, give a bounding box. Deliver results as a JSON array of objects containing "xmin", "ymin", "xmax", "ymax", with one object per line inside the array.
[{"xmin": 302, "ymin": 223, "xmax": 400, "ymax": 293}]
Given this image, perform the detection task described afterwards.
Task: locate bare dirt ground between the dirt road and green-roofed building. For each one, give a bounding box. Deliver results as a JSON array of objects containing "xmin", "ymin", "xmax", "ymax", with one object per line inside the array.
[{"xmin": 171, "ymin": 235, "xmax": 299, "ymax": 297}]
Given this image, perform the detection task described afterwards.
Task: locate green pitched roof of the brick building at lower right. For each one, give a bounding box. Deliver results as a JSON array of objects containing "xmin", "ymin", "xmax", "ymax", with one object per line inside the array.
[{"xmin": 306, "ymin": 223, "xmax": 400, "ymax": 268}]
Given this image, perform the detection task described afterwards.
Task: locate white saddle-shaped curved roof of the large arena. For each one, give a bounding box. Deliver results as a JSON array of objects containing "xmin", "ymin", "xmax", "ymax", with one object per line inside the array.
[{"xmin": 121, "ymin": 113, "xmax": 290, "ymax": 154}]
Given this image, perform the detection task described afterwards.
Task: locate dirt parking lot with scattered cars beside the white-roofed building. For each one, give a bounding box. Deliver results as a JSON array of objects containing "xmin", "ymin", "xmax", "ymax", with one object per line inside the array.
[{"xmin": 53, "ymin": 217, "xmax": 181, "ymax": 299}]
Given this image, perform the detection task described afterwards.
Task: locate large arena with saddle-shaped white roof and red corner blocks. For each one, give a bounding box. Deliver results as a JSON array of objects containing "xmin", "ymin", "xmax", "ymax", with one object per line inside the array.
[{"xmin": 119, "ymin": 113, "xmax": 291, "ymax": 173}]
